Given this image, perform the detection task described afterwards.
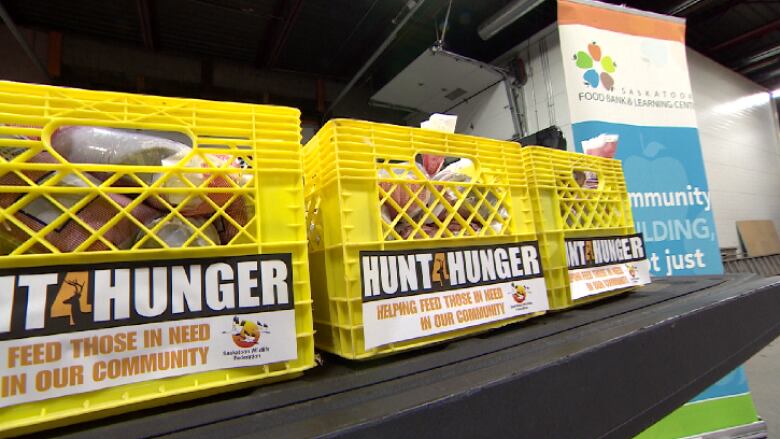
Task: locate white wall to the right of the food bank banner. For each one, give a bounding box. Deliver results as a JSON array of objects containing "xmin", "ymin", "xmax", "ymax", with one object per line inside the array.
[{"xmin": 688, "ymin": 49, "xmax": 780, "ymax": 247}]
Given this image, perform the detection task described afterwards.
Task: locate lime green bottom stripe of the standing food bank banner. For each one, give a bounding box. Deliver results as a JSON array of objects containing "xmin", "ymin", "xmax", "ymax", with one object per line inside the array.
[{"xmin": 636, "ymin": 394, "xmax": 758, "ymax": 439}]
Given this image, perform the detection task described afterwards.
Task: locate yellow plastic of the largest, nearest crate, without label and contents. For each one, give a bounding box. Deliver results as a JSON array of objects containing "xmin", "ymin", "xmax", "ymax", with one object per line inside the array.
[{"xmin": 0, "ymin": 82, "xmax": 314, "ymax": 435}]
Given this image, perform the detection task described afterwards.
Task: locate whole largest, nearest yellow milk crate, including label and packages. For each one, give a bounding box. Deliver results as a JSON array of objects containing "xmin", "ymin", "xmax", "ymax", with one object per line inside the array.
[{"xmin": 0, "ymin": 82, "xmax": 314, "ymax": 435}]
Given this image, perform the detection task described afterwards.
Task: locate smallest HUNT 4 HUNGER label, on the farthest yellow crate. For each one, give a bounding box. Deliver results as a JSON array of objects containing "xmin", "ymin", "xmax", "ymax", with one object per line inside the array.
[{"xmin": 566, "ymin": 234, "xmax": 650, "ymax": 300}]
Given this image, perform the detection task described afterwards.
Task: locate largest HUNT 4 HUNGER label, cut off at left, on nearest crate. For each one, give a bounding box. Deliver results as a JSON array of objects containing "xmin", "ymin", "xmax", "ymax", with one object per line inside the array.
[{"xmin": 0, "ymin": 254, "xmax": 297, "ymax": 407}]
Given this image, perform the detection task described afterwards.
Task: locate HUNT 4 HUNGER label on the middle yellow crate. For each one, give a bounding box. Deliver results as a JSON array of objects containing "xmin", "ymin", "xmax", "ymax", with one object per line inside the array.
[{"xmin": 360, "ymin": 242, "xmax": 548, "ymax": 349}]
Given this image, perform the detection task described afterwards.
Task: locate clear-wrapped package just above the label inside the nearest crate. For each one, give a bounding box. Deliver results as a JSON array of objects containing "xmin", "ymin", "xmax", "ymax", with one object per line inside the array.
[{"xmin": 136, "ymin": 217, "xmax": 220, "ymax": 248}]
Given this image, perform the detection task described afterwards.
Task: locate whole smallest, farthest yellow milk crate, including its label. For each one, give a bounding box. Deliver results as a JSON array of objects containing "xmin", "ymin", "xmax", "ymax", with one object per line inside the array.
[{"xmin": 522, "ymin": 146, "xmax": 650, "ymax": 309}]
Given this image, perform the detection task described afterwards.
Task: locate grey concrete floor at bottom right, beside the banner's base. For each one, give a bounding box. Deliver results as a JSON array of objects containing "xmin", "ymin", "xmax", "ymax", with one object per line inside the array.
[{"xmin": 745, "ymin": 338, "xmax": 780, "ymax": 438}]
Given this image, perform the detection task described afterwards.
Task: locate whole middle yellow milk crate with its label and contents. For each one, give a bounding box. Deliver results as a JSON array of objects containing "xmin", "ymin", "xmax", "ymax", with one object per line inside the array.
[{"xmin": 303, "ymin": 119, "xmax": 547, "ymax": 359}]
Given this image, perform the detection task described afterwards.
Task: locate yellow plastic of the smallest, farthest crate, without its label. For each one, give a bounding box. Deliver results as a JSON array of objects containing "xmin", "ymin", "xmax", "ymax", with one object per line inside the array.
[{"xmin": 522, "ymin": 146, "xmax": 635, "ymax": 309}]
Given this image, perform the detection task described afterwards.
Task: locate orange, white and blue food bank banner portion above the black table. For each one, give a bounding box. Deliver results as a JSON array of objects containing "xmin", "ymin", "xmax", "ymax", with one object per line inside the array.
[{"xmin": 559, "ymin": 0, "xmax": 723, "ymax": 276}]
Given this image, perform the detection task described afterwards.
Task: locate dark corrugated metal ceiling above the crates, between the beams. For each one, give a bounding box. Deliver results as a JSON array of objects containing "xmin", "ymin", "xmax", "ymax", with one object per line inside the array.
[{"xmin": 3, "ymin": 0, "xmax": 780, "ymax": 87}]
